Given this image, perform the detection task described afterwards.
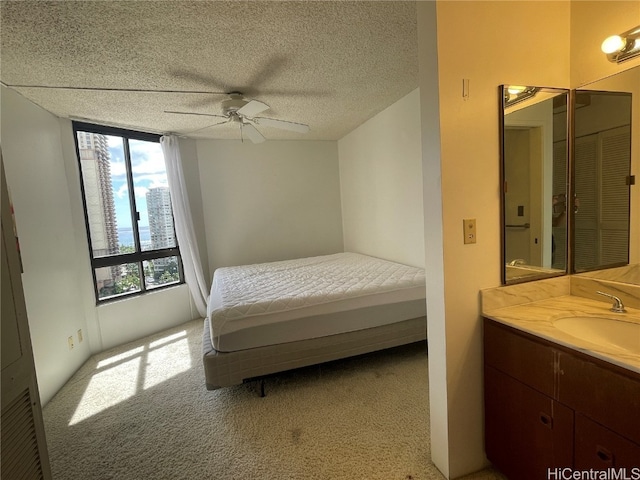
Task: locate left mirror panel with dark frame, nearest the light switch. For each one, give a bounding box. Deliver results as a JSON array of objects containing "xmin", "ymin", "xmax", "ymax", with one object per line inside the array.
[{"xmin": 500, "ymin": 85, "xmax": 569, "ymax": 284}]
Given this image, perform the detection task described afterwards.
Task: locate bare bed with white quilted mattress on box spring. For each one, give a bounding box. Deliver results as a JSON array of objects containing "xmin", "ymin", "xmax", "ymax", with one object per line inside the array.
[{"xmin": 203, "ymin": 252, "xmax": 427, "ymax": 390}]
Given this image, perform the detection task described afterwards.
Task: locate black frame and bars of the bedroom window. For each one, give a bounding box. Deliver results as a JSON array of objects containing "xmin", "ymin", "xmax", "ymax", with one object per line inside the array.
[{"xmin": 72, "ymin": 121, "xmax": 185, "ymax": 305}]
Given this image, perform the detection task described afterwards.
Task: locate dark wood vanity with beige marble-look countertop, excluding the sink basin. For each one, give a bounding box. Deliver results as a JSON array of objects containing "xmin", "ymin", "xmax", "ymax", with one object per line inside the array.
[{"xmin": 483, "ymin": 290, "xmax": 640, "ymax": 480}]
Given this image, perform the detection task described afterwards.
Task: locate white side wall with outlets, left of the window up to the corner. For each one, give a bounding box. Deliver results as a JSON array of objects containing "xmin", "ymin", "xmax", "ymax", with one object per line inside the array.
[{"xmin": 1, "ymin": 87, "xmax": 90, "ymax": 403}]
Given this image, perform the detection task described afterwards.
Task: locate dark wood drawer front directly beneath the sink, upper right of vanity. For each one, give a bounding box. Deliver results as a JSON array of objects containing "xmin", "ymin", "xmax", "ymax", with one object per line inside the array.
[{"xmin": 558, "ymin": 352, "xmax": 640, "ymax": 444}]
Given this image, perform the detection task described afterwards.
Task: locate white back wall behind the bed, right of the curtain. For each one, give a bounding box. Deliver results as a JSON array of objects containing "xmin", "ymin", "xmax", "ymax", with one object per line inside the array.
[{"xmin": 197, "ymin": 140, "xmax": 343, "ymax": 273}]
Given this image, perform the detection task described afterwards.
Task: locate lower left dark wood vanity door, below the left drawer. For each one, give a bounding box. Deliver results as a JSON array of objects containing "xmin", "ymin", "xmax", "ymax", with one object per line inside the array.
[{"xmin": 485, "ymin": 365, "xmax": 573, "ymax": 480}]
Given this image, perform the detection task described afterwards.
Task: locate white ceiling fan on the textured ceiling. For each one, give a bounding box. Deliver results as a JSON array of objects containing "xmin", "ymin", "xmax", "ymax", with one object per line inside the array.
[{"xmin": 164, "ymin": 92, "xmax": 309, "ymax": 143}]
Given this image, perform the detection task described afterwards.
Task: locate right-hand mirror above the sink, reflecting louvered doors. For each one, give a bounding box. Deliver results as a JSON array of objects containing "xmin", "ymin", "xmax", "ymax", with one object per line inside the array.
[{"xmin": 574, "ymin": 67, "xmax": 640, "ymax": 283}]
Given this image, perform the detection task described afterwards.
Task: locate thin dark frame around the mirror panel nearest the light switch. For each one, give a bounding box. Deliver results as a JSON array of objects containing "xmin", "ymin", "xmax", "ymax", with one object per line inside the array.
[{"xmin": 498, "ymin": 84, "xmax": 574, "ymax": 285}]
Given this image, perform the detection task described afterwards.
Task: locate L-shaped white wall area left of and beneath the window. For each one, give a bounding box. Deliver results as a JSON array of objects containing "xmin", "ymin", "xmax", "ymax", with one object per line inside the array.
[{"xmin": 0, "ymin": 87, "xmax": 197, "ymax": 404}]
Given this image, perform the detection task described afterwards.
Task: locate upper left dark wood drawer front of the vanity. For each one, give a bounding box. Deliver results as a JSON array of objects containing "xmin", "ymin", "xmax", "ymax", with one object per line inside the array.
[{"xmin": 484, "ymin": 318, "xmax": 555, "ymax": 397}]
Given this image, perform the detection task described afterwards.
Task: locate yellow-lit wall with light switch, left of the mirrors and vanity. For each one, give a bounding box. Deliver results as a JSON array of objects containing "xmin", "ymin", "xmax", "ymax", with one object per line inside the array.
[{"xmin": 418, "ymin": 1, "xmax": 570, "ymax": 478}]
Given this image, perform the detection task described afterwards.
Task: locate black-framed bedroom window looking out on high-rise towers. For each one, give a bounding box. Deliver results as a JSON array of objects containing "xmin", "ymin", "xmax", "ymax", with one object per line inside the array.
[{"xmin": 73, "ymin": 122, "xmax": 184, "ymax": 303}]
